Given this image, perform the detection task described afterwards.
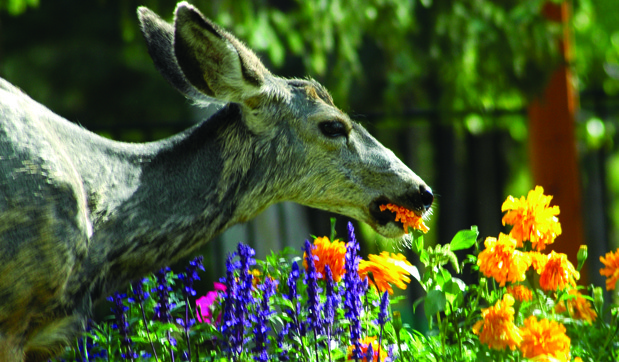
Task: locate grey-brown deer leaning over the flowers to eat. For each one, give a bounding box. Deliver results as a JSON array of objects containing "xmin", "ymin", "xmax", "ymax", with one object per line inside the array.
[{"xmin": 0, "ymin": 2, "xmax": 434, "ymax": 362}]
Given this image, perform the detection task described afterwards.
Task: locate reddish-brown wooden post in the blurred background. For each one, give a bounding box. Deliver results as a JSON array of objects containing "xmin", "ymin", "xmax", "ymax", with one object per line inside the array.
[{"xmin": 528, "ymin": 2, "xmax": 588, "ymax": 283}]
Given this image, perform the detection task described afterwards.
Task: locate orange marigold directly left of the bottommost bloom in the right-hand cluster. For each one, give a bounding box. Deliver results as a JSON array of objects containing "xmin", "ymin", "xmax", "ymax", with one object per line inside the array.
[{"xmin": 473, "ymin": 294, "xmax": 522, "ymax": 350}]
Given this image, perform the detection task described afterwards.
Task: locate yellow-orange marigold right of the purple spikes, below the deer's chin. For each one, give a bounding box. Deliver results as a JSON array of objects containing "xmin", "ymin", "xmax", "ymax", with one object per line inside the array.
[{"xmin": 359, "ymin": 251, "xmax": 413, "ymax": 294}]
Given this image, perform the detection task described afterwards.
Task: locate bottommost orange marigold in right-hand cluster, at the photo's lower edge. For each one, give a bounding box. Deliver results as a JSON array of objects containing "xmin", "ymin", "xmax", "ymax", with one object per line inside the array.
[{"xmin": 520, "ymin": 316, "xmax": 571, "ymax": 362}]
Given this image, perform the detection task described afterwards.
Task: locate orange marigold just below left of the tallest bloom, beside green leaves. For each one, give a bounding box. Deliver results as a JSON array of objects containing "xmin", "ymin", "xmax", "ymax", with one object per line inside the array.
[{"xmin": 477, "ymin": 233, "xmax": 531, "ymax": 287}]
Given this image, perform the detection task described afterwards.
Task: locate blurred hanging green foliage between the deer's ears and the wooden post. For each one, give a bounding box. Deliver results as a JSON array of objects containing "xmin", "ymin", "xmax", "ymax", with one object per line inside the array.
[{"xmin": 191, "ymin": 0, "xmax": 558, "ymax": 109}]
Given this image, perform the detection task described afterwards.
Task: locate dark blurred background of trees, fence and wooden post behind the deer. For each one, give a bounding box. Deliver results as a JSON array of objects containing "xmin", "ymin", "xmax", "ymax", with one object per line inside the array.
[{"xmin": 0, "ymin": 0, "xmax": 619, "ymax": 328}]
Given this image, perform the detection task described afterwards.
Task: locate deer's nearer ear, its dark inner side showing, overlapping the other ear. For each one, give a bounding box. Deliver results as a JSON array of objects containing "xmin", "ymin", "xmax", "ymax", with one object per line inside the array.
[{"xmin": 174, "ymin": 2, "xmax": 270, "ymax": 102}]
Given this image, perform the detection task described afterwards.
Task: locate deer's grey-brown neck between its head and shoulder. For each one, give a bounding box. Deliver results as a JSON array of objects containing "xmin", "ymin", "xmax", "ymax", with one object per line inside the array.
[{"xmin": 82, "ymin": 105, "xmax": 288, "ymax": 299}]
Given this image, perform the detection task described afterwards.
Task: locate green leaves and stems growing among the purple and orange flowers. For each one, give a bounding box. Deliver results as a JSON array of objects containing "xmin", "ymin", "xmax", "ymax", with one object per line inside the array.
[{"xmin": 50, "ymin": 222, "xmax": 619, "ymax": 362}]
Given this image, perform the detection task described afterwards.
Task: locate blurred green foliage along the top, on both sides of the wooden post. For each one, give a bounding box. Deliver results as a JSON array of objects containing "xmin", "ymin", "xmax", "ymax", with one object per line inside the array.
[{"xmin": 0, "ymin": 0, "xmax": 619, "ymax": 121}]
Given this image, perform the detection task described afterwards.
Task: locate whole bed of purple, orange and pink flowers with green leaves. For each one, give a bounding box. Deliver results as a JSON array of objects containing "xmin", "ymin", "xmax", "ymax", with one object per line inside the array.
[{"xmin": 57, "ymin": 186, "xmax": 619, "ymax": 362}]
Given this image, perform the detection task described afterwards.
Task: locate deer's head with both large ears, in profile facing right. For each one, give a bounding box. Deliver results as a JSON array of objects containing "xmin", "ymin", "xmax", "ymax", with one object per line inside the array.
[{"xmin": 138, "ymin": 2, "xmax": 433, "ymax": 237}]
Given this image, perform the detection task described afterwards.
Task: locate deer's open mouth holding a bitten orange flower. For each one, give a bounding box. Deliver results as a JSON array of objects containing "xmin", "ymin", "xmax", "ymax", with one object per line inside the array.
[{"xmin": 369, "ymin": 197, "xmax": 428, "ymax": 234}]
